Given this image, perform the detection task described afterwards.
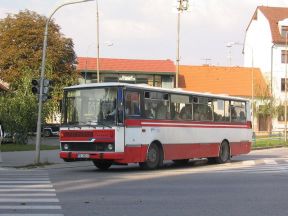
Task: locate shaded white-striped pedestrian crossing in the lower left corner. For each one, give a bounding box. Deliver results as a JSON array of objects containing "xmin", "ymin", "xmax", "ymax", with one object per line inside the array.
[{"xmin": 0, "ymin": 169, "xmax": 63, "ymax": 216}]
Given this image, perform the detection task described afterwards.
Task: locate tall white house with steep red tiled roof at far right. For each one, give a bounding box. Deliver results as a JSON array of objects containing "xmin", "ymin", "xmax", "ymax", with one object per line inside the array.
[{"xmin": 243, "ymin": 6, "xmax": 288, "ymax": 130}]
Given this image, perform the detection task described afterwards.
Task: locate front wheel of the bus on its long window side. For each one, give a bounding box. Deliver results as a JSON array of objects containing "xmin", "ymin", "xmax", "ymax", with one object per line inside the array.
[{"xmin": 139, "ymin": 143, "xmax": 163, "ymax": 170}]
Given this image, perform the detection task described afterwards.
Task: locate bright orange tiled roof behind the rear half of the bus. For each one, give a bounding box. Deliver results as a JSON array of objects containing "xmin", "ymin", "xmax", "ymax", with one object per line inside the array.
[{"xmin": 179, "ymin": 66, "xmax": 268, "ymax": 98}]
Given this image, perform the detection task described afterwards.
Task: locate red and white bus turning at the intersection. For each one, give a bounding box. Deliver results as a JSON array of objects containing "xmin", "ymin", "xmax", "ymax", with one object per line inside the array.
[{"xmin": 60, "ymin": 83, "xmax": 252, "ymax": 169}]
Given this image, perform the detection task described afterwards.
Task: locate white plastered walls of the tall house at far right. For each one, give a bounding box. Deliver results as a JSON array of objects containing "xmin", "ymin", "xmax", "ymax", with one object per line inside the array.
[{"xmin": 244, "ymin": 10, "xmax": 285, "ymax": 130}]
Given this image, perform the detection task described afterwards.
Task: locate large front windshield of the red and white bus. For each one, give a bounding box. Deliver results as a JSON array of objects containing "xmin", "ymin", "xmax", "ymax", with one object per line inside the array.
[{"xmin": 62, "ymin": 87, "xmax": 117, "ymax": 126}]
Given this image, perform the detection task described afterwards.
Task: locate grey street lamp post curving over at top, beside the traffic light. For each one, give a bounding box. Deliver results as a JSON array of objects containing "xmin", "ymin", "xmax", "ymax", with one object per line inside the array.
[{"xmin": 35, "ymin": 0, "xmax": 94, "ymax": 164}]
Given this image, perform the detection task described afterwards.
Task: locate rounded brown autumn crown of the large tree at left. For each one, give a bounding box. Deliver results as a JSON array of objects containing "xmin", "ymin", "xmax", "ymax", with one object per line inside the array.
[{"xmin": 0, "ymin": 10, "xmax": 77, "ymax": 88}]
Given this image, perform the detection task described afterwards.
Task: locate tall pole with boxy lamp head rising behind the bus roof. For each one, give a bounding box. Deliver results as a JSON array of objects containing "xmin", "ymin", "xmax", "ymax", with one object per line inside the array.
[{"xmin": 176, "ymin": 0, "xmax": 189, "ymax": 88}]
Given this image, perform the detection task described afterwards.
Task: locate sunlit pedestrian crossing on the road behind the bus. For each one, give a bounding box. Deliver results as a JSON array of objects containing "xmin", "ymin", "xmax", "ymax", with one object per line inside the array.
[{"xmin": 216, "ymin": 158, "xmax": 288, "ymax": 174}]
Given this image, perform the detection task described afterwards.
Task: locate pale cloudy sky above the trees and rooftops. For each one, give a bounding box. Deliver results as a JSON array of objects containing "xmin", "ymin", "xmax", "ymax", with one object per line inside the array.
[{"xmin": 0, "ymin": 0, "xmax": 288, "ymax": 66}]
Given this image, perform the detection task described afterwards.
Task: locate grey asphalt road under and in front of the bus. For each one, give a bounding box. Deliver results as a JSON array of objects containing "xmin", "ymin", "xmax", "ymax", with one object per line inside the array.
[{"xmin": 0, "ymin": 148, "xmax": 288, "ymax": 216}]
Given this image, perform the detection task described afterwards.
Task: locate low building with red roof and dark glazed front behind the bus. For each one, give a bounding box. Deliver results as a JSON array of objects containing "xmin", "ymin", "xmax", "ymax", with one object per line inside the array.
[{"xmin": 77, "ymin": 57, "xmax": 176, "ymax": 88}]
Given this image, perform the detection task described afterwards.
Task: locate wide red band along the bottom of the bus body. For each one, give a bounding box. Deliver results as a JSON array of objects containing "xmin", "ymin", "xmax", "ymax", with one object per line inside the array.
[{"xmin": 60, "ymin": 141, "xmax": 251, "ymax": 164}]
